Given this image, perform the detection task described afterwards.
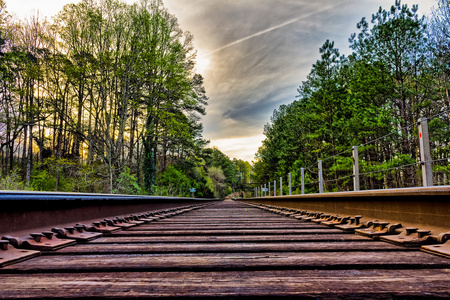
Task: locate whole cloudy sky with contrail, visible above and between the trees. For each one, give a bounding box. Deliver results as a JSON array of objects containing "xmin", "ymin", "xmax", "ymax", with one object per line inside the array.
[{"xmin": 5, "ymin": 0, "xmax": 437, "ymax": 162}]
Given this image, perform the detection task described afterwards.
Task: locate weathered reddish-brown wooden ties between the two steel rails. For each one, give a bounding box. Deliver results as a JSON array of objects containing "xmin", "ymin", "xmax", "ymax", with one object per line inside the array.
[{"xmin": 0, "ymin": 201, "xmax": 450, "ymax": 299}]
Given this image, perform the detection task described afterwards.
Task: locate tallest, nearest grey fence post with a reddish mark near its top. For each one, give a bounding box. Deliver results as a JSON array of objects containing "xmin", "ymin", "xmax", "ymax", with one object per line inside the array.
[{"xmin": 419, "ymin": 118, "xmax": 433, "ymax": 186}]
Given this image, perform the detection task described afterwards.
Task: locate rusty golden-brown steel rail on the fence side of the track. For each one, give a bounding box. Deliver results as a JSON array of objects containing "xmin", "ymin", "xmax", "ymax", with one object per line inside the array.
[{"xmin": 240, "ymin": 186, "xmax": 450, "ymax": 234}]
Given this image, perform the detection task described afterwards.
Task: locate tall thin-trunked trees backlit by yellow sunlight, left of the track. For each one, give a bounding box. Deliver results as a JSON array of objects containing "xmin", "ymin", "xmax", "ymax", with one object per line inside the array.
[{"xmin": 0, "ymin": 0, "xmax": 251, "ymax": 197}]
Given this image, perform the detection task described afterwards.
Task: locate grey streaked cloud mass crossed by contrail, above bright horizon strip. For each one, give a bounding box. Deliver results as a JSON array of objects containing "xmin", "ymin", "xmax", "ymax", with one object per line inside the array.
[{"xmin": 166, "ymin": 0, "xmax": 362, "ymax": 135}]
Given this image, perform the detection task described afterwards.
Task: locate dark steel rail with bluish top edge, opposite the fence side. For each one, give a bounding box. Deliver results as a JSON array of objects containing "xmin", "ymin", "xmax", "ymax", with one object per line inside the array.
[{"xmin": 0, "ymin": 191, "xmax": 217, "ymax": 236}]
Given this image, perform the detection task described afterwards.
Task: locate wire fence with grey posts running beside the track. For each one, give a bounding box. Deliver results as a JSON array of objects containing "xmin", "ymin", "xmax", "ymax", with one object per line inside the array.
[{"xmin": 254, "ymin": 113, "xmax": 450, "ymax": 197}]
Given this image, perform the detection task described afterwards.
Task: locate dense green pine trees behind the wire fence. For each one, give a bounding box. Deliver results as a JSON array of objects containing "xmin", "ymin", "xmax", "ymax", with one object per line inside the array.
[{"xmin": 253, "ymin": 0, "xmax": 450, "ymax": 194}]
